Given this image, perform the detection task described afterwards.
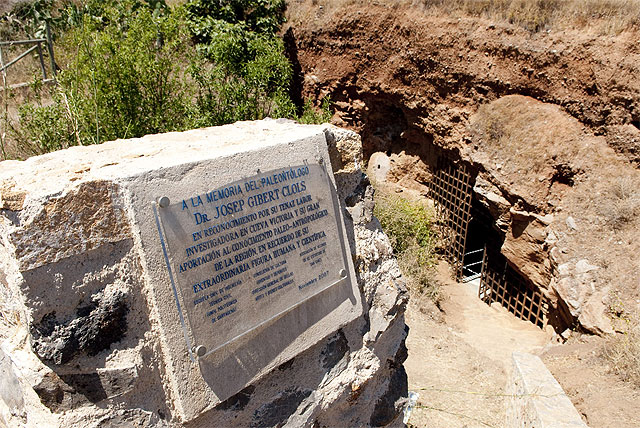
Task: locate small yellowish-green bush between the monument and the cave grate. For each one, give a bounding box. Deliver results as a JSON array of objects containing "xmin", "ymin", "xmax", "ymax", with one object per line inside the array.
[{"xmin": 374, "ymin": 192, "xmax": 440, "ymax": 304}]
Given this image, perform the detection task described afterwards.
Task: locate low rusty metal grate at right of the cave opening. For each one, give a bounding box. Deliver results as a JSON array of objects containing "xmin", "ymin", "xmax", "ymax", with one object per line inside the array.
[{"xmin": 478, "ymin": 251, "xmax": 549, "ymax": 328}]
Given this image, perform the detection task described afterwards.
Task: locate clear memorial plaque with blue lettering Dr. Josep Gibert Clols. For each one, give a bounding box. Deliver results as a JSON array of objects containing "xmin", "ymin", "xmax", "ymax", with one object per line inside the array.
[{"xmin": 154, "ymin": 164, "xmax": 348, "ymax": 358}]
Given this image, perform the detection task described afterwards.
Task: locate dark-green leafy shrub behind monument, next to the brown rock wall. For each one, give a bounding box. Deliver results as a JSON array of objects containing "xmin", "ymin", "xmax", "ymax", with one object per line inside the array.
[{"xmin": 185, "ymin": 0, "xmax": 295, "ymax": 126}]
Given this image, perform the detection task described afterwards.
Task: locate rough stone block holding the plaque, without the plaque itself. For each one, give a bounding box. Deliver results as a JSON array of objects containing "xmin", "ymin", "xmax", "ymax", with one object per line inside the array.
[{"xmin": 0, "ymin": 120, "xmax": 407, "ymax": 427}]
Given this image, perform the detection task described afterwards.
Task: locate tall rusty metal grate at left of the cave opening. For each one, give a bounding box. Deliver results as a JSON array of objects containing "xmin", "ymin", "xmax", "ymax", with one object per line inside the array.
[{"xmin": 428, "ymin": 157, "xmax": 473, "ymax": 280}]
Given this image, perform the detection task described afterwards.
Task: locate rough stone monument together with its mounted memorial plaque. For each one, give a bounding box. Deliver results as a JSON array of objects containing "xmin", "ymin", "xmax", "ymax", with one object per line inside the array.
[{"xmin": 0, "ymin": 120, "xmax": 406, "ymax": 427}]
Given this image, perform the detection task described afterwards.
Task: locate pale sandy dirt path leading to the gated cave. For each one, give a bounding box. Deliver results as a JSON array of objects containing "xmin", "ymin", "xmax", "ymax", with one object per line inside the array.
[{"xmin": 405, "ymin": 265, "xmax": 551, "ymax": 428}]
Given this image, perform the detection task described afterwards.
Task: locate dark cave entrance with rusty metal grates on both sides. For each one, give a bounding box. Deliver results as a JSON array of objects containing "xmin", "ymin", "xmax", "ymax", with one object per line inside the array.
[{"xmin": 427, "ymin": 156, "xmax": 548, "ymax": 328}]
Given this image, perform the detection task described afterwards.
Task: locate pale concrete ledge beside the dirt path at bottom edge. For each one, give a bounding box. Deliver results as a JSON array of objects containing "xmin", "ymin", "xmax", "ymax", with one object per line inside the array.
[{"xmin": 505, "ymin": 352, "xmax": 588, "ymax": 428}]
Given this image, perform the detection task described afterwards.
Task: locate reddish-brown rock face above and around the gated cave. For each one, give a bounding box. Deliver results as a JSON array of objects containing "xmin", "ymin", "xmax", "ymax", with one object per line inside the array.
[{"xmin": 287, "ymin": 1, "xmax": 640, "ymax": 332}]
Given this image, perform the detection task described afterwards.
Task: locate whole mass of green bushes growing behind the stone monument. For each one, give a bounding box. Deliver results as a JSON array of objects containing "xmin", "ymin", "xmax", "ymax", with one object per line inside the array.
[{"xmin": 13, "ymin": 0, "xmax": 295, "ymax": 154}]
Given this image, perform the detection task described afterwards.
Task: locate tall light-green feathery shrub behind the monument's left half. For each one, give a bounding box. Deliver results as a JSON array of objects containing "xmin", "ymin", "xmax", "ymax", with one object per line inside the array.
[{"xmin": 60, "ymin": 2, "xmax": 189, "ymax": 143}]
